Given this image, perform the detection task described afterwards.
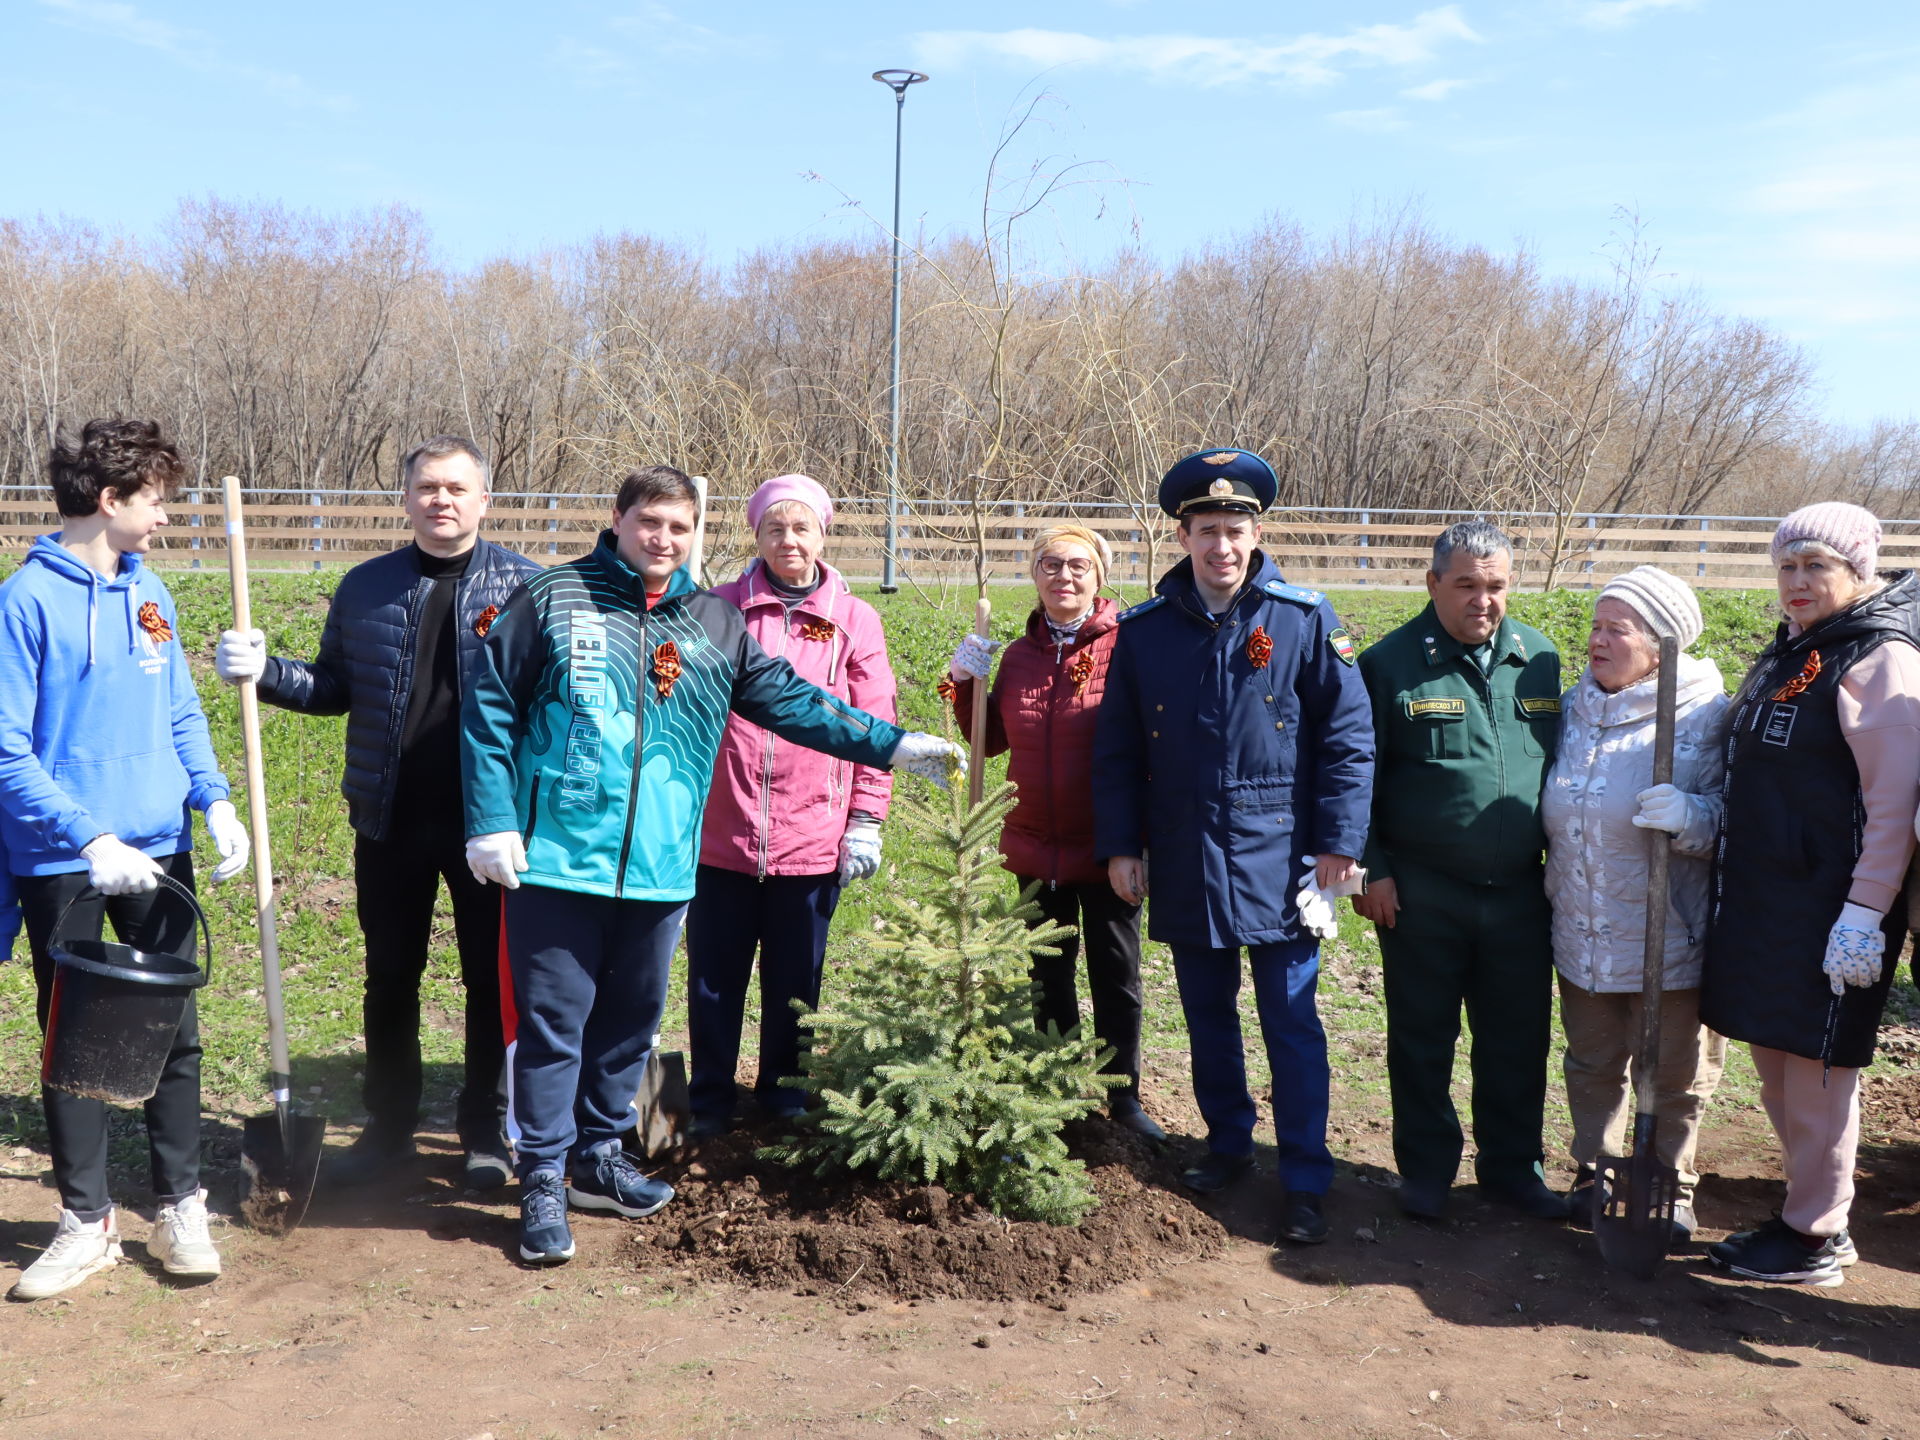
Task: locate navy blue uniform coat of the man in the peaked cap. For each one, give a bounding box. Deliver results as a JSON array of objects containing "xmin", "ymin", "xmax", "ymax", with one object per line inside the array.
[{"xmin": 1092, "ymin": 553, "xmax": 1373, "ymax": 947}]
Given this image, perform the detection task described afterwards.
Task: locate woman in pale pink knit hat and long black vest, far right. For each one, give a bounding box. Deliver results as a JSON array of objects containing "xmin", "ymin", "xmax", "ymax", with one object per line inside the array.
[{"xmin": 1699, "ymin": 503, "xmax": 1920, "ymax": 1286}]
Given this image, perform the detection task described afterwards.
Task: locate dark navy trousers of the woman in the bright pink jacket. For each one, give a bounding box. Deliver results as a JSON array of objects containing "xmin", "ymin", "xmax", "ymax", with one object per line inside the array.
[{"xmin": 687, "ymin": 866, "xmax": 841, "ymax": 1119}]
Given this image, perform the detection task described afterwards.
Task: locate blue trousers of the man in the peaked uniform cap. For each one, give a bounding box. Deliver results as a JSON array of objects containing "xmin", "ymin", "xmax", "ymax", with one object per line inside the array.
[{"xmin": 1173, "ymin": 937, "xmax": 1332, "ymax": 1194}]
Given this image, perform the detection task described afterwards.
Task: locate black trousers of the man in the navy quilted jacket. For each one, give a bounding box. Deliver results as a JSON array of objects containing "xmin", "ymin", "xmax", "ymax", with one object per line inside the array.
[{"xmin": 353, "ymin": 833, "xmax": 507, "ymax": 1150}]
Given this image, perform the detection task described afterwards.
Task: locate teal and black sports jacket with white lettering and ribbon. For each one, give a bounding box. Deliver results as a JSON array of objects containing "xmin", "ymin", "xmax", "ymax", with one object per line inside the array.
[{"xmin": 461, "ymin": 532, "xmax": 906, "ymax": 900}]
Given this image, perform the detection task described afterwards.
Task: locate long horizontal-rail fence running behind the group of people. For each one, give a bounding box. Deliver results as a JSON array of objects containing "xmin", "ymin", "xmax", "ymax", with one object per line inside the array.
[{"xmin": 0, "ymin": 488, "xmax": 1889, "ymax": 589}]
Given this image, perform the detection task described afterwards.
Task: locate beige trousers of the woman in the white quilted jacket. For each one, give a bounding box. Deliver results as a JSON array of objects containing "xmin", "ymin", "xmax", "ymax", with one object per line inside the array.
[{"xmin": 1559, "ymin": 975, "xmax": 1726, "ymax": 1204}]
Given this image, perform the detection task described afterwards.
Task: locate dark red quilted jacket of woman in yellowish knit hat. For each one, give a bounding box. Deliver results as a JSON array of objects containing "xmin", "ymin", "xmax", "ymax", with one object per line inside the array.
[{"xmin": 954, "ymin": 599, "xmax": 1119, "ymax": 885}]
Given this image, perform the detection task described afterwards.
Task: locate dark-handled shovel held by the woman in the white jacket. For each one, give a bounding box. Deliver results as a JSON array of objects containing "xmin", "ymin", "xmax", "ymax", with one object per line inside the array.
[{"xmin": 1594, "ymin": 636, "xmax": 1680, "ymax": 1281}]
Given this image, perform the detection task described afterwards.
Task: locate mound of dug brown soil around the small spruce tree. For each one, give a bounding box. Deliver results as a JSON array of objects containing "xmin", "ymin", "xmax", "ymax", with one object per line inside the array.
[{"xmin": 634, "ymin": 1119, "xmax": 1227, "ymax": 1302}]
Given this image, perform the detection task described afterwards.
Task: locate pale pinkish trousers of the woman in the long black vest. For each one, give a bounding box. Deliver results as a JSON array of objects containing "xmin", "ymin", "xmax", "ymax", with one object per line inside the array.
[{"xmin": 1747, "ymin": 1044, "xmax": 1860, "ymax": 1236}]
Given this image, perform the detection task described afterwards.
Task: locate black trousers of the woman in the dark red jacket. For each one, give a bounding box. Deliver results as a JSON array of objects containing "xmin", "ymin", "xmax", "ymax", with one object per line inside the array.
[{"xmin": 1014, "ymin": 876, "xmax": 1140, "ymax": 1100}]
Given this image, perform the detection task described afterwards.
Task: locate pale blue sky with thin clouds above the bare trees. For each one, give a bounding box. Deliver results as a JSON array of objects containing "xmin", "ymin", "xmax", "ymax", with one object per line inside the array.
[{"xmin": 11, "ymin": 0, "xmax": 1920, "ymax": 424}]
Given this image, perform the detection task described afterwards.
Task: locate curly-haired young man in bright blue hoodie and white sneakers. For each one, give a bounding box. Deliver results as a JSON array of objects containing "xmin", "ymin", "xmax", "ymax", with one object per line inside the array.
[{"xmin": 0, "ymin": 420, "xmax": 248, "ymax": 1300}]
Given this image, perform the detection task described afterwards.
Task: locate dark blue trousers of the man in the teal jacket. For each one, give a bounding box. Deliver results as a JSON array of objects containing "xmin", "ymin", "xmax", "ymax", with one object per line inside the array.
[{"xmin": 507, "ymin": 885, "xmax": 687, "ymax": 1179}]
